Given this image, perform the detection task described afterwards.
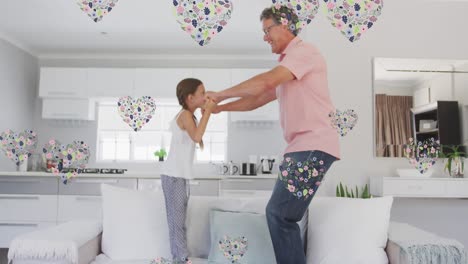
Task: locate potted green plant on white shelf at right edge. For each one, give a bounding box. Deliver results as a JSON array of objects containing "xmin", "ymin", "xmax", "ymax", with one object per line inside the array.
[{"xmin": 441, "ymin": 145, "xmax": 466, "ymax": 178}]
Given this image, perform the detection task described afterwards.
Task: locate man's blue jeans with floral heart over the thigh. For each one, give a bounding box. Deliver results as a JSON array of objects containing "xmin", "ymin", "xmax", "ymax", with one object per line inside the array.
[{"xmin": 266, "ymin": 151, "xmax": 336, "ymax": 264}]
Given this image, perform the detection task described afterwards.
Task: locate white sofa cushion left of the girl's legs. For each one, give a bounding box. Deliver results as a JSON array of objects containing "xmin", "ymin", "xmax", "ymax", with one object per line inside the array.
[{"xmin": 101, "ymin": 184, "xmax": 171, "ymax": 260}]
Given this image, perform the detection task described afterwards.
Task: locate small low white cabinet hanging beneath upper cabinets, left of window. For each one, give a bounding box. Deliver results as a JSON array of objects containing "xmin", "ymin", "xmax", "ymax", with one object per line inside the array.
[{"xmin": 42, "ymin": 98, "xmax": 96, "ymax": 120}]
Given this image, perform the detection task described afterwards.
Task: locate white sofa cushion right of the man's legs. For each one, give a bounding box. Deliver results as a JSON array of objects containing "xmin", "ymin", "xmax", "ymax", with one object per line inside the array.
[{"xmin": 307, "ymin": 197, "xmax": 393, "ymax": 264}]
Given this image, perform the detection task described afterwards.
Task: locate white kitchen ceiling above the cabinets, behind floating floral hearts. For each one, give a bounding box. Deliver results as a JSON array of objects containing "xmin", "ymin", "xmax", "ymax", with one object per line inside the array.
[{"xmin": 0, "ymin": 0, "xmax": 271, "ymax": 57}]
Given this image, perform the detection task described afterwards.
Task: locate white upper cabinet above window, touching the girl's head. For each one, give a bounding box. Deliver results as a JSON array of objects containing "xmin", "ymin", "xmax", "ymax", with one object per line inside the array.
[{"xmin": 135, "ymin": 68, "xmax": 192, "ymax": 98}]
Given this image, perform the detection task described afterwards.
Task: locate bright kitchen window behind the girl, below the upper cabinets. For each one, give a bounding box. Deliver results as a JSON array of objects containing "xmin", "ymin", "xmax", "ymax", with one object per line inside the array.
[{"xmin": 97, "ymin": 99, "xmax": 227, "ymax": 162}]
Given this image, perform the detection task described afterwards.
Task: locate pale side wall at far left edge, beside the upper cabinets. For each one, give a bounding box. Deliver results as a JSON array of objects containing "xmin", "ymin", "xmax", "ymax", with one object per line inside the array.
[{"xmin": 0, "ymin": 38, "xmax": 38, "ymax": 171}]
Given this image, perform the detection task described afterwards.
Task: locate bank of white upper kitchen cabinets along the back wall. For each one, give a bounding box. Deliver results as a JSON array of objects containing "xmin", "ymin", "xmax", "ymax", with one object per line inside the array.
[{"xmin": 39, "ymin": 68, "xmax": 279, "ymax": 121}]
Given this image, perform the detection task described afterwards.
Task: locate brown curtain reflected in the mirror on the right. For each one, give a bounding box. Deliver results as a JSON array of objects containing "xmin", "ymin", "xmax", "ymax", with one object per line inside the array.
[{"xmin": 375, "ymin": 94, "xmax": 413, "ymax": 157}]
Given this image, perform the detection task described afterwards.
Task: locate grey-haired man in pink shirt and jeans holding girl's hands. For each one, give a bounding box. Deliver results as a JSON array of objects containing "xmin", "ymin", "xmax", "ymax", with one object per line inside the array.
[{"xmin": 207, "ymin": 6, "xmax": 340, "ymax": 264}]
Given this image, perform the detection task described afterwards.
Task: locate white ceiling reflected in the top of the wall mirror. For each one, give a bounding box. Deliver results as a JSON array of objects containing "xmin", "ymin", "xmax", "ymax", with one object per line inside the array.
[{"xmin": 374, "ymin": 58, "xmax": 468, "ymax": 87}]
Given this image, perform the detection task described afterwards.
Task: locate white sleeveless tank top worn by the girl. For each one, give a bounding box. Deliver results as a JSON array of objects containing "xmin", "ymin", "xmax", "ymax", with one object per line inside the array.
[{"xmin": 161, "ymin": 110, "xmax": 198, "ymax": 179}]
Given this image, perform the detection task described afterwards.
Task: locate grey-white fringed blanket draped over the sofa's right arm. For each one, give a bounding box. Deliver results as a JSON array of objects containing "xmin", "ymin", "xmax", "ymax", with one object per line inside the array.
[{"xmin": 389, "ymin": 222, "xmax": 467, "ymax": 264}]
